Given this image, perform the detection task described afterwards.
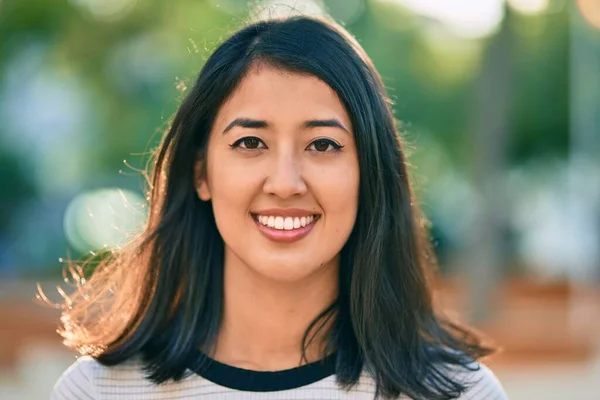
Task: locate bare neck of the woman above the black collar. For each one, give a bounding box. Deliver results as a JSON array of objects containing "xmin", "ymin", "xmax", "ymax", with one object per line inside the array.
[{"xmin": 214, "ymin": 252, "xmax": 339, "ymax": 371}]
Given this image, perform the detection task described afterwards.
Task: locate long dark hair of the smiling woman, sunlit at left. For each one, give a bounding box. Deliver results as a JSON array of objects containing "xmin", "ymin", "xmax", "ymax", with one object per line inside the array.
[{"xmin": 52, "ymin": 17, "xmax": 492, "ymax": 399}]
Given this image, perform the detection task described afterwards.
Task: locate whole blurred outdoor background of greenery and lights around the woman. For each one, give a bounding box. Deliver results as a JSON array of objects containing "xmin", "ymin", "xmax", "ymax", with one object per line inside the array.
[{"xmin": 0, "ymin": 0, "xmax": 600, "ymax": 400}]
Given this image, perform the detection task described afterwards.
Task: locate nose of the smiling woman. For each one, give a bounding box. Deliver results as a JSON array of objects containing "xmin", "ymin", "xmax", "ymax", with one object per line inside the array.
[{"xmin": 263, "ymin": 153, "xmax": 308, "ymax": 199}]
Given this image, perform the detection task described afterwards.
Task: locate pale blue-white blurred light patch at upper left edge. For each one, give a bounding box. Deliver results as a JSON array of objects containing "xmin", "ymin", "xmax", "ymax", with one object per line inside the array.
[{"xmin": 0, "ymin": 40, "xmax": 93, "ymax": 195}]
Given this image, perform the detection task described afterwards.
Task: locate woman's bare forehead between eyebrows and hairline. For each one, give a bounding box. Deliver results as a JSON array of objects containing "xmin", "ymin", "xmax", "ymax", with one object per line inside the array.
[{"xmin": 217, "ymin": 64, "xmax": 350, "ymax": 126}]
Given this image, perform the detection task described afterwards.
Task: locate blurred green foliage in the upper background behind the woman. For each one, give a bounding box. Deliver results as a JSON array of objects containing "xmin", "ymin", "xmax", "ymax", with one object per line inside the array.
[{"xmin": 0, "ymin": 0, "xmax": 569, "ymax": 276}]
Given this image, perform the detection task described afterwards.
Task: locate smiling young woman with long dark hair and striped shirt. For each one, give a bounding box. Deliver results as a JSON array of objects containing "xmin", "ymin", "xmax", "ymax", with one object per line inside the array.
[{"xmin": 52, "ymin": 17, "xmax": 505, "ymax": 400}]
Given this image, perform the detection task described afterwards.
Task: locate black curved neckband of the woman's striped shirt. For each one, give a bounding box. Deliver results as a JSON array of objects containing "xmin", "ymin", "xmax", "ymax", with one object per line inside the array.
[{"xmin": 190, "ymin": 352, "xmax": 336, "ymax": 392}]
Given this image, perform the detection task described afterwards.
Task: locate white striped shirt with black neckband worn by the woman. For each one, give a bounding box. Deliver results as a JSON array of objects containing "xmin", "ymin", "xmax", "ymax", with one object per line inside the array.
[{"xmin": 51, "ymin": 356, "xmax": 508, "ymax": 400}]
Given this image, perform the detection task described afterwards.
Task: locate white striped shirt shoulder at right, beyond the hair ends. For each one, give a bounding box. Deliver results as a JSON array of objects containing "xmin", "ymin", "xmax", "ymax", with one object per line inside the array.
[{"xmin": 456, "ymin": 363, "xmax": 508, "ymax": 400}]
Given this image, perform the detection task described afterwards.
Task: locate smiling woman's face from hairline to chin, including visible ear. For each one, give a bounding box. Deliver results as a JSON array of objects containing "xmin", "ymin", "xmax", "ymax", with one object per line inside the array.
[{"xmin": 196, "ymin": 65, "xmax": 359, "ymax": 282}]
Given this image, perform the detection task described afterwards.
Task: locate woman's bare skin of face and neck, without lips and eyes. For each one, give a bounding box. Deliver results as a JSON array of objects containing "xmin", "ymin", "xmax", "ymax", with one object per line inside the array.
[{"xmin": 196, "ymin": 65, "xmax": 359, "ymax": 370}]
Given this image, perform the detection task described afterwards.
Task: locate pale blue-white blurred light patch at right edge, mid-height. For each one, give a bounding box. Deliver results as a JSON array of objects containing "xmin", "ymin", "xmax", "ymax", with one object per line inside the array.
[{"xmin": 507, "ymin": 159, "xmax": 600, "ymax": 279}]
